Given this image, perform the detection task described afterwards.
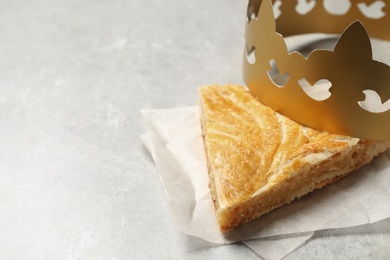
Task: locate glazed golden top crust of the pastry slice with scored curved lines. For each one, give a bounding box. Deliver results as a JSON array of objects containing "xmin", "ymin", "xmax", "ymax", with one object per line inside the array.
[{"xmin": 203, "ymin": 87, "xmax": 357, "ymax": 204}]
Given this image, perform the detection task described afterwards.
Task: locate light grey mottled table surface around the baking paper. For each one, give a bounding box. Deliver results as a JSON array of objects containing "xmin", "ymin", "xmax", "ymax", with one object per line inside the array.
[{"xmin": 0, "ymin": 0, "xmax": 390, "ymax": 259}]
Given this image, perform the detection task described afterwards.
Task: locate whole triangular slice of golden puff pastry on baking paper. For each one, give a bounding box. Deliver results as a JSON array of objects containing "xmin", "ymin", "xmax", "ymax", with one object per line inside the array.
[{"xmin": 199, "ymin": 85, "xmax": 390, "ymax": 231}]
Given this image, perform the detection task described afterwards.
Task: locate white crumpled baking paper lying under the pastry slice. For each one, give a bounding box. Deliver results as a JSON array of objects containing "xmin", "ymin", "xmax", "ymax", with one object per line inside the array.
[{"xmin": 141, "ymin": 107, "xmax": 390, "ymax": 259}]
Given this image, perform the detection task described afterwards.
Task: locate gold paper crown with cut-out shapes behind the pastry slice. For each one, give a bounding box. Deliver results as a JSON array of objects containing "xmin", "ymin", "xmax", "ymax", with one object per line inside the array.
[{"xmin": 243, "ymin": 0, "xmax": 390, "ymax": 140}]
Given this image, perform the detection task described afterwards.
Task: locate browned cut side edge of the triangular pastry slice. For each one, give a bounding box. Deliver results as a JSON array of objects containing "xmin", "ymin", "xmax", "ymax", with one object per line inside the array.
[{"xmin": 215, "ymin": 139, "xmax": 388, "ymax": 232}]
